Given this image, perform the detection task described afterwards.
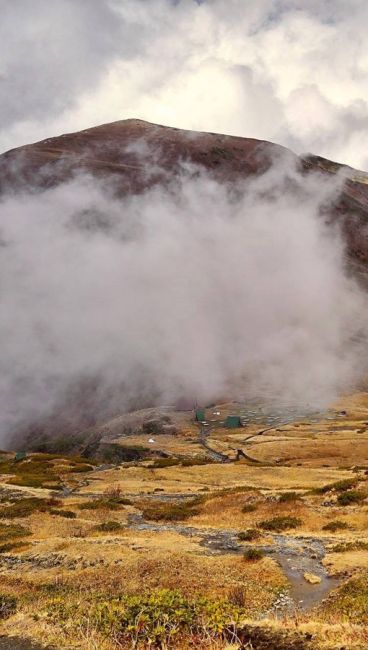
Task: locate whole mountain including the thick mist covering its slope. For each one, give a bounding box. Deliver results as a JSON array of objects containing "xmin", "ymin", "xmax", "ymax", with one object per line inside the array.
[{"xmin": 0, "ymin": 120, "xmax": 368, "ymax": 444}]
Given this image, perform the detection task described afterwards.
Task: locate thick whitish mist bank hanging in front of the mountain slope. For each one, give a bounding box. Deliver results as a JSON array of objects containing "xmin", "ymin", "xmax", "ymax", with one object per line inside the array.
[{"xmin": 0, "ymin": 156, "xmax": 367, "ymax": 438}]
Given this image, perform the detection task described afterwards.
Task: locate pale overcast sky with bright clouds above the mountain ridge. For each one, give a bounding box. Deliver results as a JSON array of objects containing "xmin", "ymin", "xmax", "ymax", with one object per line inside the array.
[{"xmin": 0, "ymin": 0, "xmax": 368, "ymax": 169}]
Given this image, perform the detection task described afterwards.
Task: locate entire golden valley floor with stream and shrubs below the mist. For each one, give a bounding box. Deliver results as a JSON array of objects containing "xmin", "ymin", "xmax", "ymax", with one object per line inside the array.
[{"xmin": 0, "ymin": 393, "xmax": 368, "ymax": 650}]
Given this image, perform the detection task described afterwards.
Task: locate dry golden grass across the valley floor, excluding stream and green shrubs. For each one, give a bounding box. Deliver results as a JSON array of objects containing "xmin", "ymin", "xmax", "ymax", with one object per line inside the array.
[{"xmin": 0, "ymin": 394, "xmax": 368, "ymax": 650}]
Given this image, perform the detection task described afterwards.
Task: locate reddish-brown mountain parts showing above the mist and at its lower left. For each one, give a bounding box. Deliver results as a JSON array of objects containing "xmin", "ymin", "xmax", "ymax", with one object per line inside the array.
[{"xmin": 0, "ymin": 119, "xmax": 368, "ymax": 444}]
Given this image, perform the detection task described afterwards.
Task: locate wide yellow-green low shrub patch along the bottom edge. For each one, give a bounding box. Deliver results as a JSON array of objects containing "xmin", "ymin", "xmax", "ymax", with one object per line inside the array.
[{"xmin": 47, "ymin": 589, "xmax": 241, "ymax": 649}]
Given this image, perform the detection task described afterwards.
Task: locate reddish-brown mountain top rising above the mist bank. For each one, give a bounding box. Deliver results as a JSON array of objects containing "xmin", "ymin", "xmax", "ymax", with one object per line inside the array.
[{"xmin": 0, "ymin": 119, "xmax": 368, "ymax": 272}]
